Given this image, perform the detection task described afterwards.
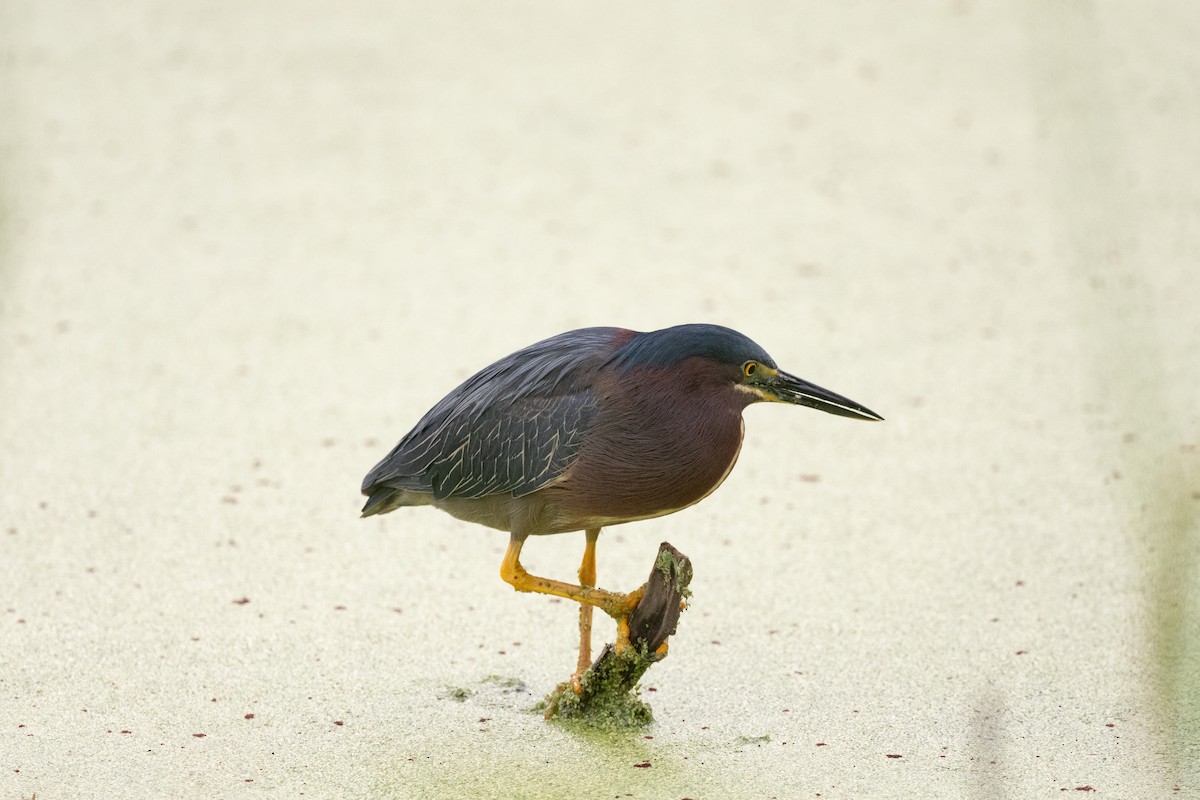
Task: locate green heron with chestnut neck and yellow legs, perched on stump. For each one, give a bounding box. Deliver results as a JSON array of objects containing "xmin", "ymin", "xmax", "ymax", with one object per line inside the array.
[{"xmin": 362, "ymin": 325, "xmax": 883, "ymax": 686}]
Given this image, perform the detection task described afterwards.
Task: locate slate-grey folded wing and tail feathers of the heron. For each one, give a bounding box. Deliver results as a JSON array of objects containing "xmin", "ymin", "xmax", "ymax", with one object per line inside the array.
[{"xmin": 362, "ymin": 327, "xmax": 620, "ymax": 516}]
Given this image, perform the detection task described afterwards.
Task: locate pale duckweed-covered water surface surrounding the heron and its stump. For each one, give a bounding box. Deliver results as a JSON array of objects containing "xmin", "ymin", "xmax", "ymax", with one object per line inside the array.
[{"xmin": 0, "ymin": 0, "xmax": 1200, "ymax": 800}]
